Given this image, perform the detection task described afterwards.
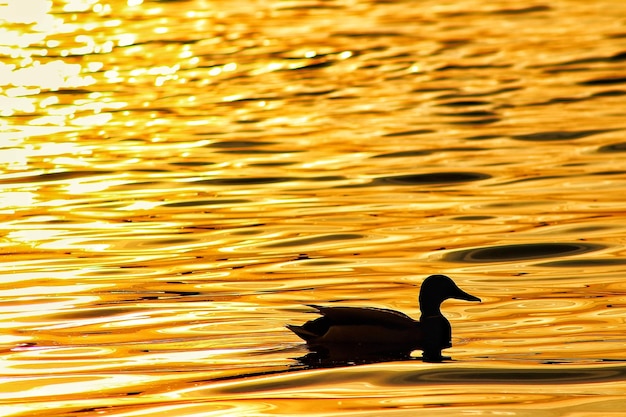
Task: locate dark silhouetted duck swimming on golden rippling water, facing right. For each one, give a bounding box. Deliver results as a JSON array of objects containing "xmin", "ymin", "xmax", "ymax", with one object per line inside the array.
[{"xmin": 286, "ymin": 275, "xmax": 481, "ymax": 362}]
